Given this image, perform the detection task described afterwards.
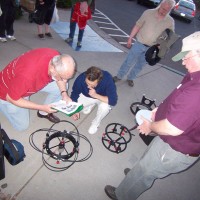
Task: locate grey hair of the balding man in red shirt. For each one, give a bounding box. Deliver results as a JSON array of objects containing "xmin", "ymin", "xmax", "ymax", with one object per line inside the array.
[{"xmin": 51, "ymin": 54, "xmax": 76, "ymax": 73}]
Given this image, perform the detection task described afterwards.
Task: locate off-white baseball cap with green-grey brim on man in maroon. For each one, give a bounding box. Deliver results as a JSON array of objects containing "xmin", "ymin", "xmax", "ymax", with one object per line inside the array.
[{"xmin": 172, "ymin": 31, "xmax": 200, "ymax": 62}]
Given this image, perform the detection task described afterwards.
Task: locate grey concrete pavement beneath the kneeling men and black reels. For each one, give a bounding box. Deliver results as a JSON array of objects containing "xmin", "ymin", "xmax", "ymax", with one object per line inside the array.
[{"xmin": 0, "ymin": 10, "xmax": 200, "ymax": 200}]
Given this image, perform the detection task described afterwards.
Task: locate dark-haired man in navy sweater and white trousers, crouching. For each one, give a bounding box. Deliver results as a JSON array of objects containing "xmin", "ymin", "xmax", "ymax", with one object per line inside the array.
[{"xmin": 71, "ymin": 66, "xmax": 118, "ymax": 134}]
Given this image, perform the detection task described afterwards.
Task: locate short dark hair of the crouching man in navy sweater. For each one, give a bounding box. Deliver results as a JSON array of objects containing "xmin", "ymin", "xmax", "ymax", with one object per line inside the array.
[{"xmin": 85, "ymin": 66, "xmax": 103, "ymax": 82}]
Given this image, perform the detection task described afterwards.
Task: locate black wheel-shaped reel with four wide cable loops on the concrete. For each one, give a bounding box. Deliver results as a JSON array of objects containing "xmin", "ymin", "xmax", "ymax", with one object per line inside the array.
[{"xmin": 29, "ymin": 120, "xmax": 93, "ymax": 172}]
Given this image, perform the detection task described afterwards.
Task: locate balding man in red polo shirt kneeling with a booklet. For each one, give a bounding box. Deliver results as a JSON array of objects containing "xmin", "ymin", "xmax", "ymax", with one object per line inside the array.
[{"xmin": 0, "ymin": 48, "xmax": 76, "ymax": 130}]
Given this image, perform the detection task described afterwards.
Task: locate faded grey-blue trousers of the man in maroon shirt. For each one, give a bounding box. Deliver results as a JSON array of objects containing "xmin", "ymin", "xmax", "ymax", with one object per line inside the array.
[{"xmin": 116, "ymin": 136, "xmax": 198, "ymax": 200}]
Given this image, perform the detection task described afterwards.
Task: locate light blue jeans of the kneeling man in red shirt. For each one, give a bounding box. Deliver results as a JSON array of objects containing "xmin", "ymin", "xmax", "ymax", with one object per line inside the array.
[{"xmin": 0, "ymin": 81, "xmax": 65, "ymax": 131}]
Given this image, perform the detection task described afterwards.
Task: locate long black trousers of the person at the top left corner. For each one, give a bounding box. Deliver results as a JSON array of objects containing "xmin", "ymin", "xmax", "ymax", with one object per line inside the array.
[{"xmin": 0, "ymin": 6, "xmax": 16, "ymax": 37}]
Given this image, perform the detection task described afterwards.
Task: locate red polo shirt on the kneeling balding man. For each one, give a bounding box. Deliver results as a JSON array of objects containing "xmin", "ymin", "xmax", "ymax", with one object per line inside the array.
[{"xmin": 0, "ymin": 48, "xmax": 60, "ymax": 100}]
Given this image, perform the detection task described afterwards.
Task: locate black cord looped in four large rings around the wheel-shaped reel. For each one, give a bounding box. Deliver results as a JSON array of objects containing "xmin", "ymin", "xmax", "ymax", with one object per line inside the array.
[{"xmin": 29, "ymin": 120, "xmax": 93, "ymax": 172}]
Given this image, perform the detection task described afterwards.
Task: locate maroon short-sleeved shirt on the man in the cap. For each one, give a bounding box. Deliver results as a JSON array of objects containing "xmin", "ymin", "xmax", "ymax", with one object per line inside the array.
[{"xmin": 155, "ymin": 71, "xmax": 200, "ymax": 154}]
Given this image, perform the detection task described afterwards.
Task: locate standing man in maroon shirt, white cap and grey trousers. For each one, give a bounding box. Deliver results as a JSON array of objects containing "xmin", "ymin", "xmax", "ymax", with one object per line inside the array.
[{"xmin": 105, "ymin": 31, "xmax": 200, "ymax": 200}]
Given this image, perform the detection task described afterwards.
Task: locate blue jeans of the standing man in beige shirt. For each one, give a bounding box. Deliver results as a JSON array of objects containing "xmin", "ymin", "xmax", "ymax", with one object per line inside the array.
[{"xmin": 117, "ymin": 41, "xmax": 148, "ymax": 80}]
